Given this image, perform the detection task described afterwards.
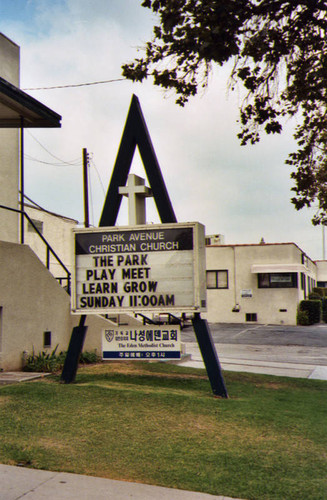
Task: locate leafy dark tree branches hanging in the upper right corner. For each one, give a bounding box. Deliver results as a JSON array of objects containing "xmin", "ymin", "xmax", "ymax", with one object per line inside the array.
[{"xmin": 123, "ymin": 0, "xmax": 327, "ymax": 224}]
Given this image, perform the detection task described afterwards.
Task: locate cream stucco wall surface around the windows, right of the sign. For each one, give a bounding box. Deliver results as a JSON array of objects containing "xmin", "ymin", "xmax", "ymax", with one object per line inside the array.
[{"xmin": 206, "ymin": 243, "xmax": 316, "ymax": 325}]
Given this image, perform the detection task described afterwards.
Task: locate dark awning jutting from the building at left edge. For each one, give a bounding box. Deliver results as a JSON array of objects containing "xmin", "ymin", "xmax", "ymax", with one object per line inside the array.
[{"xmin": 0, "ymin": 77, "xmax": 61, "ymax": 128}]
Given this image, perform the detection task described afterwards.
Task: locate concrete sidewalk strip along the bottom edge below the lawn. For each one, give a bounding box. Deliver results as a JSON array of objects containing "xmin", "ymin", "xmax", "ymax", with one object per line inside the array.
[{"xmin": 0, "ymin": 465, "xmax": 240, "ymax": 500}]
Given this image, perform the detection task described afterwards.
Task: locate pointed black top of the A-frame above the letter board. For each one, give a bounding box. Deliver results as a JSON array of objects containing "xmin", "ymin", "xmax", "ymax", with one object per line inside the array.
[{"xmin": 99, "ymin": 95, "xmax": 177, "ymax": 227}]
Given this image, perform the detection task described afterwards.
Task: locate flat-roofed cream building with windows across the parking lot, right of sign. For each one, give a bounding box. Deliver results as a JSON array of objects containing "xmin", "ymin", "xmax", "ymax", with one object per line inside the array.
[{"xmin": 206, "ymin": 243, "xmax": 320, "ymax": 325}]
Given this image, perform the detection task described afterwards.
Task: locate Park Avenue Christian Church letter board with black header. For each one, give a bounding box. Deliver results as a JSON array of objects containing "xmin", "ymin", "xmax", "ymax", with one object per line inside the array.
[{"xmin": 72, "ymin": 222, "xmax": 206, "ymax": 314}]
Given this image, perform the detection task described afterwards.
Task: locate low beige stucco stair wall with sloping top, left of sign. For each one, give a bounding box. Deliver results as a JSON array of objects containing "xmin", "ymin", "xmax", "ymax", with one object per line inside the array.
[{"xmin": 0, "ymin": 242, "xmax": 108, "ymax": 370}]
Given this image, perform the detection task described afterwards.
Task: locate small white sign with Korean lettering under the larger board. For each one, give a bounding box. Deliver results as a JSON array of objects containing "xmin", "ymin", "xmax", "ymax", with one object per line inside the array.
[{"xmin": 102, "ymin": 325, "xmax": 181, "ymax": 361}]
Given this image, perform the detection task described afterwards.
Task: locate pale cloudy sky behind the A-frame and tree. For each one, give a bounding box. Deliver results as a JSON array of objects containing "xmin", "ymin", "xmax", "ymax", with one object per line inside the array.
[{"xmin": 0, "ymin": 0, "xmax": 323, "ymax": 260}]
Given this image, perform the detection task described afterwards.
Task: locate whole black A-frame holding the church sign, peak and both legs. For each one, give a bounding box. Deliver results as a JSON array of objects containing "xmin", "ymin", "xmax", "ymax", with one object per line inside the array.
[{"xmin": 61, "ymin": 95, "xmax": 228, "ymax": 398}]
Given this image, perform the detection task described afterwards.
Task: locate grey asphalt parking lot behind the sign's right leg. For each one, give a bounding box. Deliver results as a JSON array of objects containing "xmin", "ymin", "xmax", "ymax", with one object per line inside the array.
[{"xmin": 182, "ymin": 323, "xmax": 327, "ymax": 380}]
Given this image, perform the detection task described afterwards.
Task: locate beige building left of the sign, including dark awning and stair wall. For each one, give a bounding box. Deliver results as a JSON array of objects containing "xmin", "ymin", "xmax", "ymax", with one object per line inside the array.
[{"xmin": 0, "ymin": 34, "xmax": 114, "ymax": 370}]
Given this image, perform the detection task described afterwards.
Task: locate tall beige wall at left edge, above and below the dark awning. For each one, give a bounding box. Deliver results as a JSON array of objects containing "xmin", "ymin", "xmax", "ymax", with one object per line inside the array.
[{"xmin": 0, "ymin": 33, "xmax": 19, "ymax": 242}]
